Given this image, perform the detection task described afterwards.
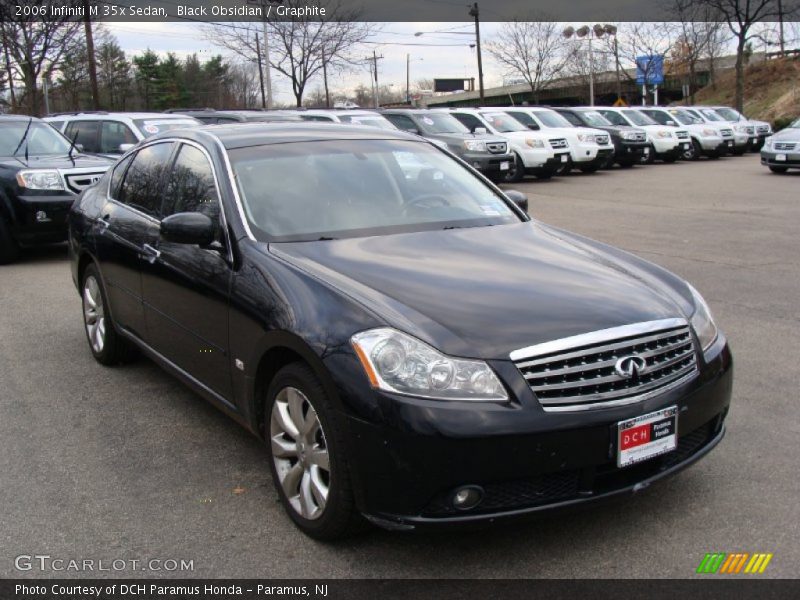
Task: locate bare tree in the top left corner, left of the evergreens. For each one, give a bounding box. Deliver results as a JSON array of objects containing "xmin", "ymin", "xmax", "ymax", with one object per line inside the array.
[{"xmin": 0, "ymin": 0, "xmax": 81, "ymax": 115}]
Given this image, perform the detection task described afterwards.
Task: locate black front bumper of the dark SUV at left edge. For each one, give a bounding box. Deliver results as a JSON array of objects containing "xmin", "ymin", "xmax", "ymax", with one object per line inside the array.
[{"xmin": 7, "ymin": 194, "xmax": 76, "ymax": 246}]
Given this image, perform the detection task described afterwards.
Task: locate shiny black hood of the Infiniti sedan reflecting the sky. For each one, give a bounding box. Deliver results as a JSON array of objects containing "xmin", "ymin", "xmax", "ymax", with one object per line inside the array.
[{"xmin": 269, "ymin": 222, "xmax": 691, "ymax": 359}]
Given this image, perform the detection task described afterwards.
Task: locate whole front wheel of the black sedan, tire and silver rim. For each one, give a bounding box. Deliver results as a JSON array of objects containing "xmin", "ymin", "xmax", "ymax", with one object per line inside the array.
[{"xmin": 264, "ymin": 362, "xmax": 364, "ymax": 540}]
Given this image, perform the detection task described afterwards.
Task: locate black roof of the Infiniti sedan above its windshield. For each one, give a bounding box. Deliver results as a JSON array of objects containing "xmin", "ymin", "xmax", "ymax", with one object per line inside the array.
[{"xmin": 148, "ymin": 121, "xmax": 425, "ymax": 150}]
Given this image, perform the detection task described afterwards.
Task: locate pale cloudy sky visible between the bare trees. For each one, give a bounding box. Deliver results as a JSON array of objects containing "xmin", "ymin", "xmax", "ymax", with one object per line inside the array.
[{"xmin": 103, "ymin": 22, "xmax": 503, "ymax": 104}]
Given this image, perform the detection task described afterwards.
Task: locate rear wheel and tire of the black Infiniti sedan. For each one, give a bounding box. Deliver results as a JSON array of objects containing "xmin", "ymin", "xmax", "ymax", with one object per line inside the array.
[{"xmin": 81, "ymin": 264, "xmax": 136, "ymax": 366}]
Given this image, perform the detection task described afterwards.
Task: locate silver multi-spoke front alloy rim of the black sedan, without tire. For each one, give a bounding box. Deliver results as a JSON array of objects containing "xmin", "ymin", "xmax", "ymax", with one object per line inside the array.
[{"xmin": 270, "ymin": 387, "xmax": 331, "ymax": 520}]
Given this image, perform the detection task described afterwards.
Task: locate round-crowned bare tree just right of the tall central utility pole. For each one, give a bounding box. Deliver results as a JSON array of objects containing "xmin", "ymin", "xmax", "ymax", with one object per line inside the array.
[{"xmin": 486, "ymin": 15, "xmax": 570, "ymax": 103}]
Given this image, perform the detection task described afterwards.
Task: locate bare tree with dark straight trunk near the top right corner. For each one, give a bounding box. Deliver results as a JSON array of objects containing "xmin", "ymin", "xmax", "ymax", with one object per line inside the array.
[{"xmin": 698, "ymin": 0, "xmax": 798, "ymax": 112}]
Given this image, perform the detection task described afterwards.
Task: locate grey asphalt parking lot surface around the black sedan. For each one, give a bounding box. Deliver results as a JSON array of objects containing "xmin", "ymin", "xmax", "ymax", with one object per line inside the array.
[{"xmin": 0, "ymin": 155, "xmax": 800, "ymax": 578}]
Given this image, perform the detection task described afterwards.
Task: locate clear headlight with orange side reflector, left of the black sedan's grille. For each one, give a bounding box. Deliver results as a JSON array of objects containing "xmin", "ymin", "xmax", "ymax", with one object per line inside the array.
[{"xmin": 350, "ymin": 327, "xmax": 508, "ymax": 400}]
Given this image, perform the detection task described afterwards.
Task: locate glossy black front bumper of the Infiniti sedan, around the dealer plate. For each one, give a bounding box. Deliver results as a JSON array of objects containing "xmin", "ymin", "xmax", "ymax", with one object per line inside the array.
[{"xmin": 347, "ymin": 338, "xmax": 732, "ymax": 529}]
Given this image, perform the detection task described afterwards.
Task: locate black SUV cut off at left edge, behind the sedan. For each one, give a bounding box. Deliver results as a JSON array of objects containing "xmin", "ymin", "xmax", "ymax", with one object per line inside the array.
[{"xmin": 0, "ymin": 115, "xmax": 112, "ymax": 264}]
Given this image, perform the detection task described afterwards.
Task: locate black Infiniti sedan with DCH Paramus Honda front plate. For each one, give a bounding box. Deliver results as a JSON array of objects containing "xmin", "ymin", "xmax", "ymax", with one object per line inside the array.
[{"xmin": 69, "ymin": 123, "xmax": 732, "ymax": 539}]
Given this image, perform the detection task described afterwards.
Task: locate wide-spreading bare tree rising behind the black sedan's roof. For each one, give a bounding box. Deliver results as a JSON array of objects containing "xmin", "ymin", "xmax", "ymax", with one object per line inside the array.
[{"xmin": 206, "ymin": 0, "xmax": 374, "ymax": 106}]
